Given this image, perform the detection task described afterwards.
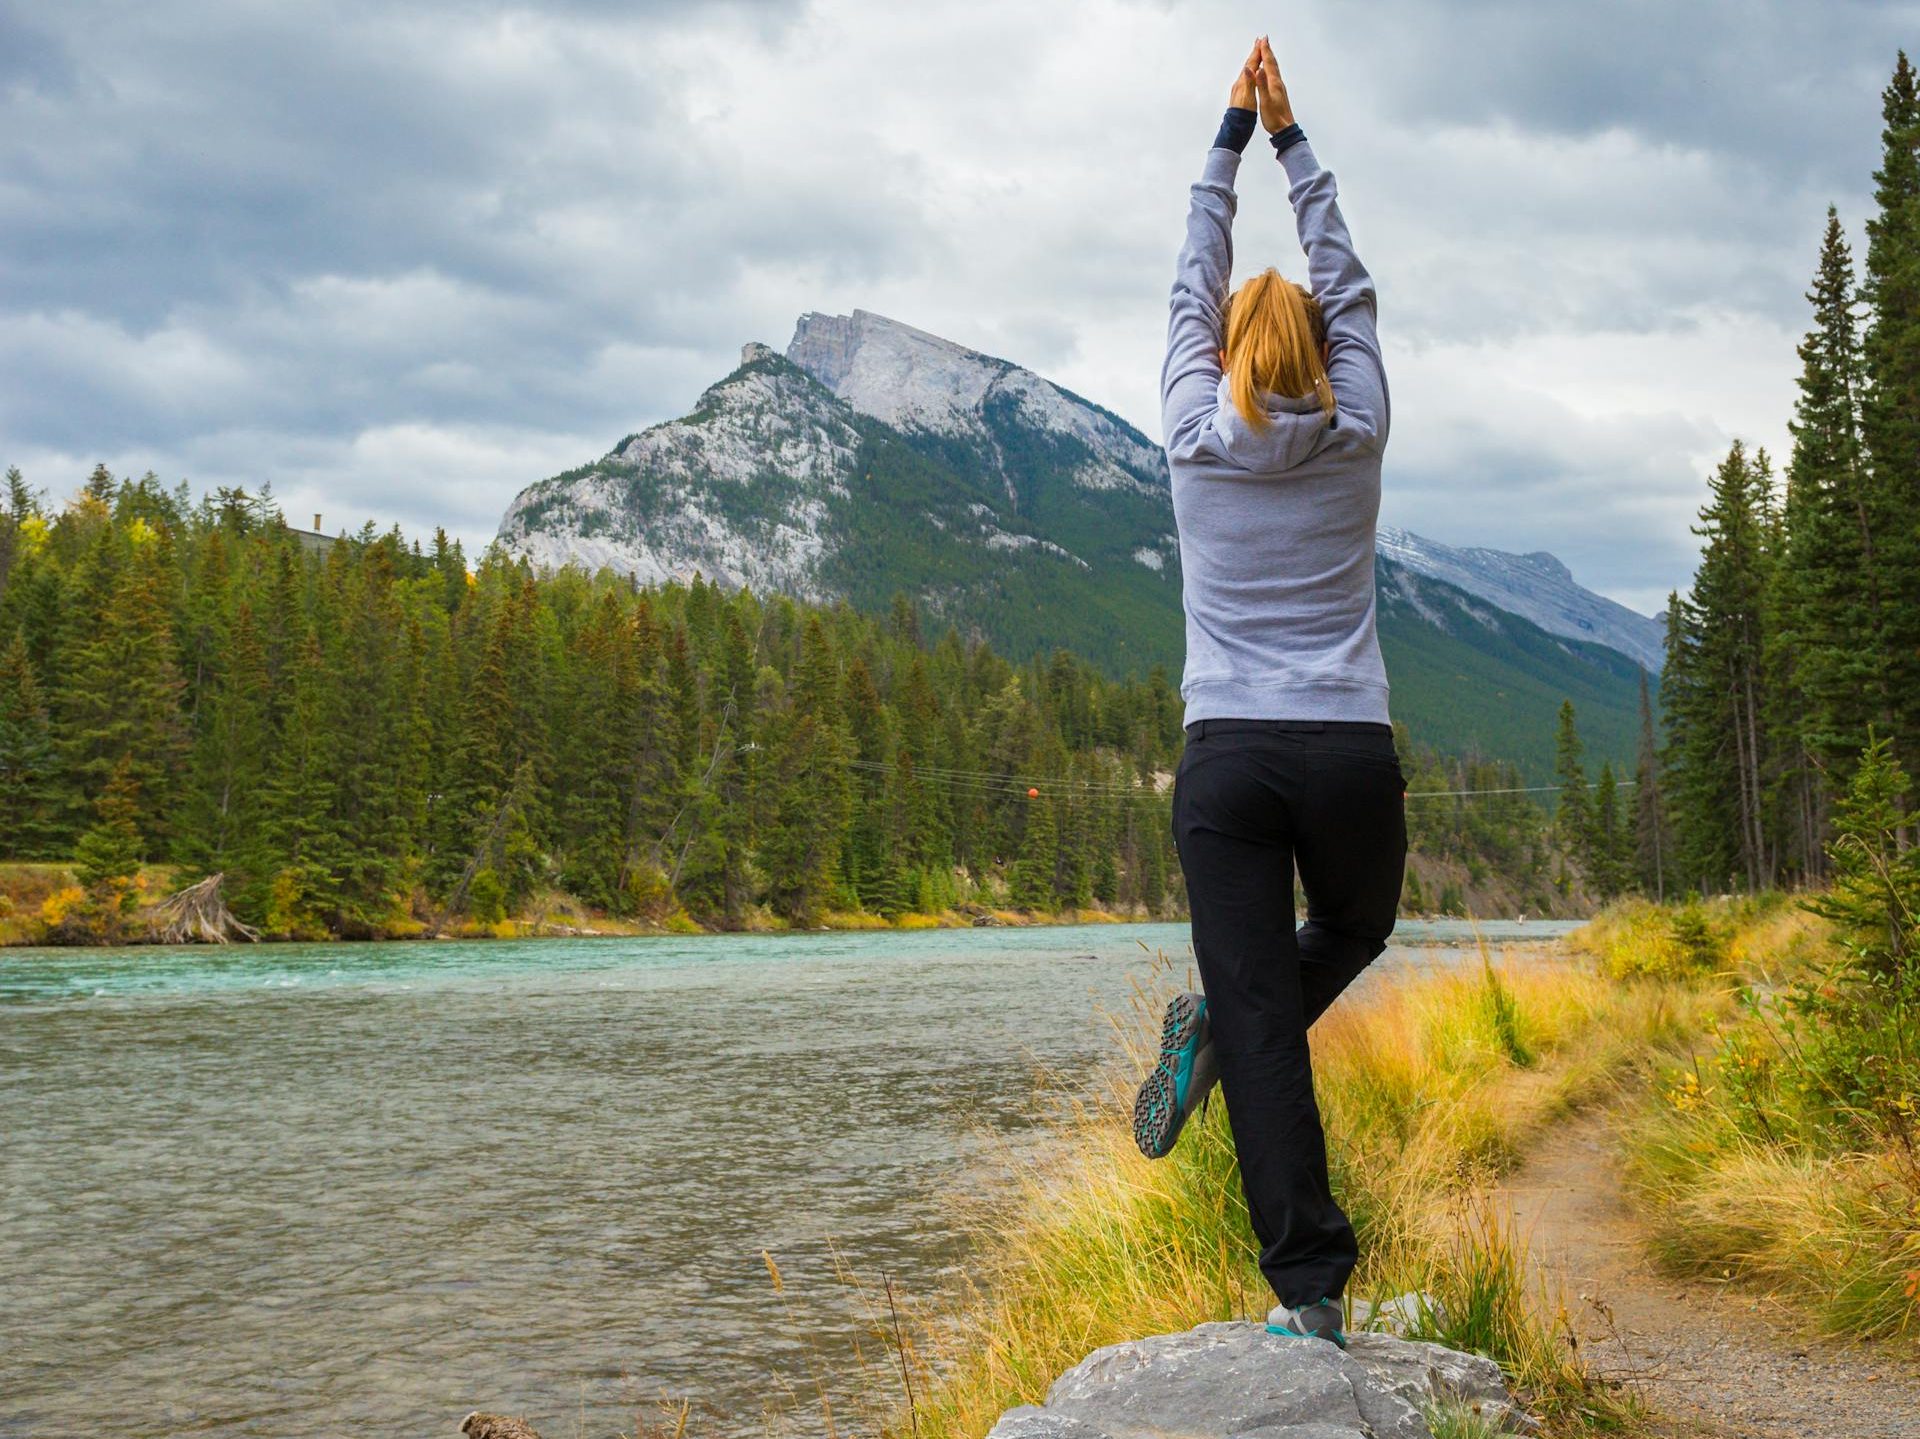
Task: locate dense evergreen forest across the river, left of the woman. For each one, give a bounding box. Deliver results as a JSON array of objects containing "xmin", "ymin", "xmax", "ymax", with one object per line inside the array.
[{"xmin": 0, "ymin": 469, "xmax": 1181, "ymax": 936}]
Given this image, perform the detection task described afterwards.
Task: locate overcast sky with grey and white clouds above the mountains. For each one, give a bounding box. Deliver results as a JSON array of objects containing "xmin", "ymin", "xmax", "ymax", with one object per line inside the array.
[{"xmin": 0, "ymin": 0, "xmax": 1920, "ymax": 611}]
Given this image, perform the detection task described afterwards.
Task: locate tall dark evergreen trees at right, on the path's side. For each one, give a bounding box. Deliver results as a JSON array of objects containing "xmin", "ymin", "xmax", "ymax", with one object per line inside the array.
[{"xmin": 1559, "ymin": 52, "xmax": 1920, "ymax": 897}]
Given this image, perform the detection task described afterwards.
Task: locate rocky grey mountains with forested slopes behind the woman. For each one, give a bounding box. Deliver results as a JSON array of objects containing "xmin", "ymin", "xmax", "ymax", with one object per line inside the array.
[{"xmin": 499, "ymin": 309, "xmax": 1657, "ymax": 770}]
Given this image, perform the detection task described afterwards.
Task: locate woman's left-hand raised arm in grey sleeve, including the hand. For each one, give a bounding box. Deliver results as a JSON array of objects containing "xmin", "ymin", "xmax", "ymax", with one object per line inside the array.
[{"xmin": 1160, "ymin": 44, "xmax": 1260, "ymax": 446}]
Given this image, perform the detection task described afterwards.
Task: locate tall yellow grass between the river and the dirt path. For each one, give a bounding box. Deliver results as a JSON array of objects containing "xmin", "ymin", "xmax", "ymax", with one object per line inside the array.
[{"xmin": 874, "ymin": 941, "xmax": 1699, "ymax": 1439}]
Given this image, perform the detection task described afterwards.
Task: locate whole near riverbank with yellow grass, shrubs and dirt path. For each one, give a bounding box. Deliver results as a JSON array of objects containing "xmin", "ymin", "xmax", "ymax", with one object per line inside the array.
[{"xmin": 872, "ymin": 895, "xmax": 1920, "ymax": 1439}]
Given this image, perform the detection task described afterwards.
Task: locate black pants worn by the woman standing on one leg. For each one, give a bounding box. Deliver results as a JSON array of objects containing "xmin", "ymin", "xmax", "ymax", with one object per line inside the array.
[{"xmin": 1173, "ymin": 719, "xmax": 1407, "ymax": 1306}]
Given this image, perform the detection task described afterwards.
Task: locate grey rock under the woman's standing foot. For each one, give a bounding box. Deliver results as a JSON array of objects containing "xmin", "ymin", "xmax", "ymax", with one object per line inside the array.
[{"xmin": 989, "ymin": 1324, "xmax": 1530, "ymax": 1439}]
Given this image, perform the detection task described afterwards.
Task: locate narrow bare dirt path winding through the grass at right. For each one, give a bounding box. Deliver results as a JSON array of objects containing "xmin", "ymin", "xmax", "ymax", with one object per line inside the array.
[{"xmin": 1505, "ymin": 1114, "xmax": 1920, "ymax": 1439}]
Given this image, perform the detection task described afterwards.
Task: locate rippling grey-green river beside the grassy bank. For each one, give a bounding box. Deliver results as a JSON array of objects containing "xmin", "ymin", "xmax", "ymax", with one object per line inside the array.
[{"xmin": 0, "ymin": 922, "xmax": 1569, "ymax": 1439}]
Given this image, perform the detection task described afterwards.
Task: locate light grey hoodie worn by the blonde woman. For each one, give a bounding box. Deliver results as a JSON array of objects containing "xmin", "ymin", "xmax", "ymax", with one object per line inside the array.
[{"xmin": 1160, "ymin": 140, "xmax": 1388, "ymax": 724}]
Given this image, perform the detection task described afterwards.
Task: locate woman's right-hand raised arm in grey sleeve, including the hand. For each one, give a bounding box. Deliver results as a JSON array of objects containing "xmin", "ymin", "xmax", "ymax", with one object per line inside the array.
[{"xmin": 1256, "ymin": 38, "xmax": 1388, "ymax": 448}]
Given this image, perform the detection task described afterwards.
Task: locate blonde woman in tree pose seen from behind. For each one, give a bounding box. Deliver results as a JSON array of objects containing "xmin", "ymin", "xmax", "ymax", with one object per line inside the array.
[{"xmin": 1135, "ymin": 38, "xmax": 1407, "ymax": 1345}]
